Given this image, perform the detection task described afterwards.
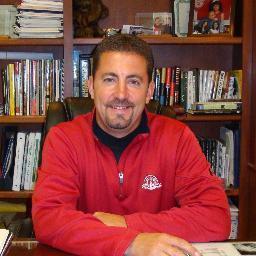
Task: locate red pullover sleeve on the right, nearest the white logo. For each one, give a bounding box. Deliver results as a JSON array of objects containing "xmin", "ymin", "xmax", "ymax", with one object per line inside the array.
[{"xmin": 125, "ymin": 127, "xmax": 231, "ymax": 242}]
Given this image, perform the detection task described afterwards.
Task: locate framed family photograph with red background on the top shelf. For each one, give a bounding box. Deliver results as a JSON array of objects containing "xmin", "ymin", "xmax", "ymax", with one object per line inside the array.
[{"xmin": 189, "ymin": 0, "xmax": 235, "ymax": 36}]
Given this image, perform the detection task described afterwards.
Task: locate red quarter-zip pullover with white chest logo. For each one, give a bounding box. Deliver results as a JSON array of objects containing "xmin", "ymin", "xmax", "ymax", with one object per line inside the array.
[{"xmin": 32, "ymin": 113, "xmax": 230, "ymax": 256}]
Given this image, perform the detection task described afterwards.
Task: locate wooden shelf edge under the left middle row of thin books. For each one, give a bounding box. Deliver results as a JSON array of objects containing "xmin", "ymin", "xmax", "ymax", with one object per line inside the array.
[{"xmin": 0, "ymin": 116, "xmax": 45, "ymax": 124}]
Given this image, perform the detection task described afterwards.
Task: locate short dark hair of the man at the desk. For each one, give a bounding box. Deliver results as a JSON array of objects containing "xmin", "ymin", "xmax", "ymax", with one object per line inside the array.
[{"xmin": 92, "ymin": 34, "xmax": 154, "ymax": 81}]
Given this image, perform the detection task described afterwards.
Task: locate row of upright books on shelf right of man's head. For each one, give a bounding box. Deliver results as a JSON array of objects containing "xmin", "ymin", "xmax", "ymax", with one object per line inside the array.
[{"xmin": 153, "ymin": 66, "xmax": 242, "ymax": 112}]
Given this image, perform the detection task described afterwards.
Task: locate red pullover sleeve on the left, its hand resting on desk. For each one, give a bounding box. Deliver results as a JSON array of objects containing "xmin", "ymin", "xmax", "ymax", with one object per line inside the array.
[{"xmin": 32, "ymin": 128, "xmax": 138, "ymax": 256}]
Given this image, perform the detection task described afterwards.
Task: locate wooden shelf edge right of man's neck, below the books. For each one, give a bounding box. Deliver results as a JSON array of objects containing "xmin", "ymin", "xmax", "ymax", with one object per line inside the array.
[{"xmin": 177, "ymin": 114, "xmax": 241, "ymax": 122}]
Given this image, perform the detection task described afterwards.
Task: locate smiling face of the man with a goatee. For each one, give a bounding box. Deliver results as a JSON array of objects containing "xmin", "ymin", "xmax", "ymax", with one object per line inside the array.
[{"xmin": 89, "ymin": 51, "xmax": 154, "ymax": 138}]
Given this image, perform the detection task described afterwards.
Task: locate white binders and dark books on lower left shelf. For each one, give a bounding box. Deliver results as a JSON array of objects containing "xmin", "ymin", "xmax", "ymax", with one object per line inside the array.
[{"xmin": 0, "ymin": 131, "xmax": 41, "ymax": 191}]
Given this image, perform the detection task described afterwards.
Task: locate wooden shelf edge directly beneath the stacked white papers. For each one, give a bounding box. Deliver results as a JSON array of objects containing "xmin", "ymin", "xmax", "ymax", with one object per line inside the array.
[{"xmin": 0, "ymin": 37, "xmax": 64, "ymax": 46}]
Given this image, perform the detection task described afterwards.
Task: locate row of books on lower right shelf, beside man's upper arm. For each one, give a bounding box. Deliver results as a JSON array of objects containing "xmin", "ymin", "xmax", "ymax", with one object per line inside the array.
[{"xmin": 198, "ymin": 125, "xmax": 240, "ymax": 188}]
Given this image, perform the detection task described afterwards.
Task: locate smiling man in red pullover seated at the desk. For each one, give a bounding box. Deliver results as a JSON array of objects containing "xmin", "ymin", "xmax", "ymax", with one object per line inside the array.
[{"xmin": 32, "ymin": 35, "xmax": 230, "ymax": 256}]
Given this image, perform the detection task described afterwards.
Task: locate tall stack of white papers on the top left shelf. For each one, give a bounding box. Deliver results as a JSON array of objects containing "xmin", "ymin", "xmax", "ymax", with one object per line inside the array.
[{"xmin": 14, "ymin": 0, "xmax": 63, "ymax": 38}]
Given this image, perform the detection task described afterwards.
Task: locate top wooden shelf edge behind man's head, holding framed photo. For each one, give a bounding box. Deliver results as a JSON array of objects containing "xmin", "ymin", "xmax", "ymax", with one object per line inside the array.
[{"xmin": 73, "ymin": 35, "xmax": 242, "ymax": 45}]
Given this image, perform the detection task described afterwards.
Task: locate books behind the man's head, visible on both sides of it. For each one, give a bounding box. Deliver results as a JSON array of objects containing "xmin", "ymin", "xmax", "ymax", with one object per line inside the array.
[{"xmin": 73, "ymin": 50, "xmax": 242, "ymax": 113}]
